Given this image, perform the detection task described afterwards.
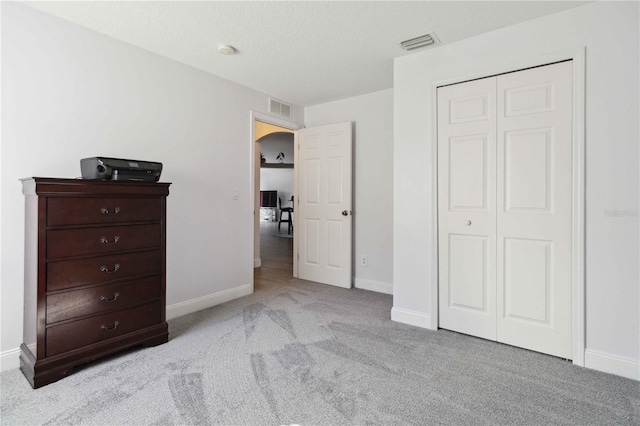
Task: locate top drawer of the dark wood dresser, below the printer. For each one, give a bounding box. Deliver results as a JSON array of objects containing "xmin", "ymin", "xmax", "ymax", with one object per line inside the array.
[{"xmin": 47, "ymin": 197, "xmax": 162, "ymax": 226}]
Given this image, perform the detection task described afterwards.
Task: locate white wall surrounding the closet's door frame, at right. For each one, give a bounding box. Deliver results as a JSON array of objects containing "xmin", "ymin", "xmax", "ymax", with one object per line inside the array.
[{"xmin": 392, "ymin": 2, "xmax": 640, "ymax": 379}]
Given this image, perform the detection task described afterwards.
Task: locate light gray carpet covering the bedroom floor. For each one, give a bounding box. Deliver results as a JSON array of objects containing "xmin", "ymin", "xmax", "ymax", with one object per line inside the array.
[{"xmin": 0, "ymin": 280, "xmax": 640, "ymax": 425}]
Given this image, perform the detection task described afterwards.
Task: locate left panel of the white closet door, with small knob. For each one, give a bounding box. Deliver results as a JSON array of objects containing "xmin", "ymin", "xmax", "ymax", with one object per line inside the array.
[{"xmin": 438, "ymin": 77, "xmax": 496, "ymax": 340}]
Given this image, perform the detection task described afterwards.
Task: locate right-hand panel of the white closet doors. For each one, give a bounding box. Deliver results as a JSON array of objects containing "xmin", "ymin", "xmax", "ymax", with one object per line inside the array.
[{"xmin": 497, "ymin": 62, "xmax": 573, "ymax": 359}]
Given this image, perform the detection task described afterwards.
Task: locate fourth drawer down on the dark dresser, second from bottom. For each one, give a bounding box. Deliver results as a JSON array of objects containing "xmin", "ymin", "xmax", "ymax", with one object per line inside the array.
[{"xmin": 47, "ymin": 275, "xmax": 161, "ymax": 324}]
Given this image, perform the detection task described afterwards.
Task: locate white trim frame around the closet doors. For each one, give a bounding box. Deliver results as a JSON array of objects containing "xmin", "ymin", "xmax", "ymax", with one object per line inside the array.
[{"xmin": 429, "ymin": 47, "xmax": 586, "ymax": 367}]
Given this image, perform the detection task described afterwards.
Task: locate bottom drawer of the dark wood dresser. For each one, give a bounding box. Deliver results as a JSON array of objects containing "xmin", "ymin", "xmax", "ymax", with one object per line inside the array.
[{"xmin": 46, "ymin": 301, "xmax": 161, "ymax": 357}]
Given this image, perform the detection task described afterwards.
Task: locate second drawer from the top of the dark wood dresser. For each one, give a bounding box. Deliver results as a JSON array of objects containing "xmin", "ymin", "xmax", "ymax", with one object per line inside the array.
[{"xmin": 47, "ymin": 224, "xmax": 160, "ymax": 259}]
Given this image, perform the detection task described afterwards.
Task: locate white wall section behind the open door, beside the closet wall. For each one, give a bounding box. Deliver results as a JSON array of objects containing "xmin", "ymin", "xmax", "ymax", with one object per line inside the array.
[{"xmin": 305, "ymin": 89, "xmax": 394, "ymax": 293}]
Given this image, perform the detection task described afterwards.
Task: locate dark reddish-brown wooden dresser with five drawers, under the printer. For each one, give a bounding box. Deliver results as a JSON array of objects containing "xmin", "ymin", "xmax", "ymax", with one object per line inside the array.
[{"xmin": 20, "ymin": 178, "xmax": 170, "ymax": 388}]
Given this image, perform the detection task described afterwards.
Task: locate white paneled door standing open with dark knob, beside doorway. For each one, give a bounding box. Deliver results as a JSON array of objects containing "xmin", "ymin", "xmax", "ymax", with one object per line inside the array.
[{"xmin": 294, "ymin": 122, "xmax": 353, "ymax": 288}]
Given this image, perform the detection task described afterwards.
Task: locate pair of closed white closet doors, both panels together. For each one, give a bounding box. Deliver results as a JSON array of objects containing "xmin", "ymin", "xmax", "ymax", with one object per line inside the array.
[{"xmin": 438, "ymin": 62, "xmax": 572, "ymax": 358}]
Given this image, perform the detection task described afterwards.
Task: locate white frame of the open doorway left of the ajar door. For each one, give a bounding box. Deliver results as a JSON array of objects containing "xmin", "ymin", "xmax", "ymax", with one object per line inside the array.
[{"xmin": 249, "ymin": 110, "xmax": 304, "ymax": 293}]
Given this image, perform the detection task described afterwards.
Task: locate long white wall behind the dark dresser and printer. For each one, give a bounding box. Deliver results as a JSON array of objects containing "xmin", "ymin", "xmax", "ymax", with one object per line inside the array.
[{"xmin": 0, "ymin": 2, "xmax": 303, "ymax": 369}]
